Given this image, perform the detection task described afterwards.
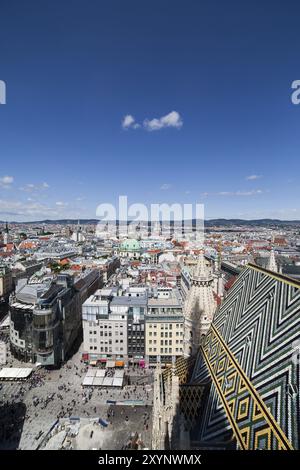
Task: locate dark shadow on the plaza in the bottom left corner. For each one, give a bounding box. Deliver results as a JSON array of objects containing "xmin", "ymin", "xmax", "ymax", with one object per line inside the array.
[{"xmin": 0, "ymin": 403, "xmax": 26, "ymax": 450}]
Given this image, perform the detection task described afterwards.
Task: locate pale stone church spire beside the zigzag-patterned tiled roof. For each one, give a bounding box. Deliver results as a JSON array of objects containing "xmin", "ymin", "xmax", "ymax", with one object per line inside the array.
[{"xmin": 184, "ymin": 252, "xmax": 217, "ymax": 357}]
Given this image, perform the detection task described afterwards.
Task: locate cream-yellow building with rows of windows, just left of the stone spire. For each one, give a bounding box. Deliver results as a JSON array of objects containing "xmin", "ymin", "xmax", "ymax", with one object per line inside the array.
[{"xmin": 145, "ymin": 288, "xmax": 184, "ymax": 365}]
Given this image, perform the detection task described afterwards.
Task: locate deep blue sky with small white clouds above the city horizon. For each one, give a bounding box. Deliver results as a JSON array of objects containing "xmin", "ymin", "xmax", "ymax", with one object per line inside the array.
[{"xmin": 0, "ymin": 0, "xmax": 300, "ymax": 220}]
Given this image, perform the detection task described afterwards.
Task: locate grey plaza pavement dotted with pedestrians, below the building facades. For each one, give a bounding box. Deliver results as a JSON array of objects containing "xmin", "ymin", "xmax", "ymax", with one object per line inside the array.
[{"xmin": 0, "ymin": 351, "xmax": 153, "ymax": 449}]
